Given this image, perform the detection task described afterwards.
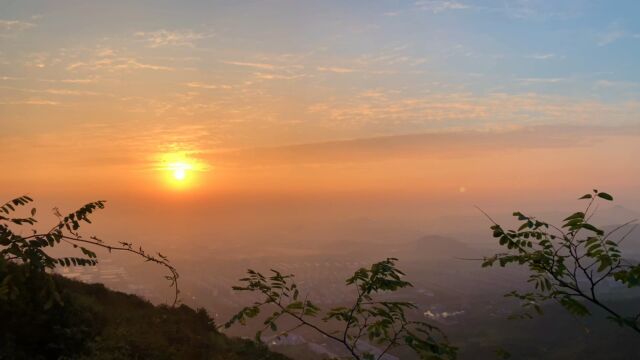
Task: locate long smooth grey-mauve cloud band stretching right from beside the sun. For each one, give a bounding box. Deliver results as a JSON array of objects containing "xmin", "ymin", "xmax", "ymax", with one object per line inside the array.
[{"xmin": 205, "ymin": 126, "xmax": 640, "ymax": 166}]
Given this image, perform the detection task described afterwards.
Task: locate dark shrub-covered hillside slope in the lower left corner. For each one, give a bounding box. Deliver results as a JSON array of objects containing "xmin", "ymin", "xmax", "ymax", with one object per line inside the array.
[{"xmin": 0, "ymin": 263, "xmax": 287, "ymax": 360}]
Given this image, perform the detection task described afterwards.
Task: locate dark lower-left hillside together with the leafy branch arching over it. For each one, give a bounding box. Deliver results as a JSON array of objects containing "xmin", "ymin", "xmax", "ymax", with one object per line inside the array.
[{"xmin": 0, "ymin": 196, "xmax": 286, "ymax": 360}]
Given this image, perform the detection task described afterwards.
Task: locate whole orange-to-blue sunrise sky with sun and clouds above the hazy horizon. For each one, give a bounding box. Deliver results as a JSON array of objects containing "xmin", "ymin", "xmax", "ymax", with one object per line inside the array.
[{"xmin": 0, "ymin": 0, "xmax": 640, "ymax": 232}]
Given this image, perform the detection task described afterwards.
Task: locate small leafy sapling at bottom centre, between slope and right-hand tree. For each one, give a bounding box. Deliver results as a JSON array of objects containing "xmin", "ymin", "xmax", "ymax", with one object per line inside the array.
[{"xmin": 224, "ymin": 258, "xmax": 456, "ymax": 360}]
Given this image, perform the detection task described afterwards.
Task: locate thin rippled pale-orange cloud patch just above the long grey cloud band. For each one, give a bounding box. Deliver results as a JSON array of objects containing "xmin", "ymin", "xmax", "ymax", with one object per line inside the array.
[{"xmin": 307, "ymin": 93, "xmax": 639, "ymax": 133}]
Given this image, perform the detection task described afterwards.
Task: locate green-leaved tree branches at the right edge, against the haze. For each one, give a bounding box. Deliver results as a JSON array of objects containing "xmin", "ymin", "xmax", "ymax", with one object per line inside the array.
[{"xmin": 481, "ymin": 190, "xmax": 640, "ymax": 334}]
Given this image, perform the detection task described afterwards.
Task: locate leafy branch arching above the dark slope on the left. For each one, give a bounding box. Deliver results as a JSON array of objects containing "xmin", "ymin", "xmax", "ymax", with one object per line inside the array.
[{"xmin": 0, "ymin": 196, "xmax": 179, "ymax": 308}]
